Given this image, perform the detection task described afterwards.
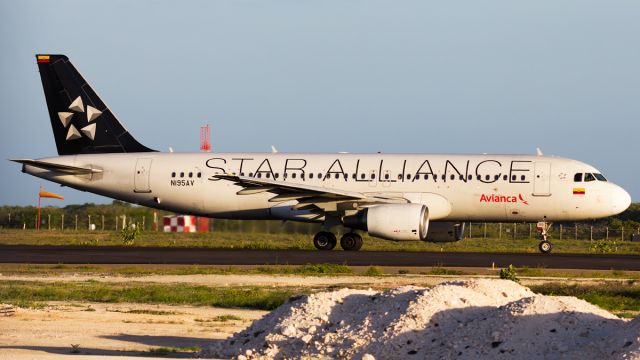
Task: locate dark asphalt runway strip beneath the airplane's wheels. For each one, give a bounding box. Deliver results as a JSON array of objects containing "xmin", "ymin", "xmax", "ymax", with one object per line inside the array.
[{"xmin": 0, "ymin": 245, "xmax": 640, "ymax": 271}]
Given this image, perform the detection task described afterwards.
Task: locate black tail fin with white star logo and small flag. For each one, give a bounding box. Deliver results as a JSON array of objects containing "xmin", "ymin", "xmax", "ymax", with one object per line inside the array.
[{"xmin": 36, "ymin": 55, "xmax": 155, "ymax": 155}]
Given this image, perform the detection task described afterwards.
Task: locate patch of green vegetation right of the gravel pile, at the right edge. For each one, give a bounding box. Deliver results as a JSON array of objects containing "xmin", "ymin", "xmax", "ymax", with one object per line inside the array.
[{"xmin": 530, "ymin": 283, "xmax": 640, "ymax": 316}]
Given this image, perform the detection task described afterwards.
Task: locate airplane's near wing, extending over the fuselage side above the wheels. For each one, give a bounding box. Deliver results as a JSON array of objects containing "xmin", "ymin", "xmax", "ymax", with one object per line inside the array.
[{"xmin": 214, "ymin": 175, "xmax": 408, "ymax": 207}]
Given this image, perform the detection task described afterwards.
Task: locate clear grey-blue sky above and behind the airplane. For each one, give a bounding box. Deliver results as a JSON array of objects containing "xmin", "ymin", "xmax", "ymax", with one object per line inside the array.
[{"xmin": 0, "ymin": 0, "xmax": 640, "ymax": 205}]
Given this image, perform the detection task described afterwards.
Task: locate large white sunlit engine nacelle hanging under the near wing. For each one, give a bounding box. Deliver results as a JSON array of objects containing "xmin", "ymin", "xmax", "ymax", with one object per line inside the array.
[{"xmin": 342, "ymin": 204, "xmax": 429, "ymax": 240}]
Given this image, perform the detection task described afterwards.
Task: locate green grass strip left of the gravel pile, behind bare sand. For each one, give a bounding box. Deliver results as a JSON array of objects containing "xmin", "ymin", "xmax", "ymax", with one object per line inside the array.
[{"xmin": 0, "ymin": 281, "xmax": 308, "ymax": 310}]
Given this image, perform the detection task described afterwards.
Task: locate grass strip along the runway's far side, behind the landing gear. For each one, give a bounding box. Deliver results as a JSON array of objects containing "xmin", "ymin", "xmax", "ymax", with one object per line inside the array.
[{"xmin": 0, "ymin": 229, "xmax": 640, "ymax": 254}]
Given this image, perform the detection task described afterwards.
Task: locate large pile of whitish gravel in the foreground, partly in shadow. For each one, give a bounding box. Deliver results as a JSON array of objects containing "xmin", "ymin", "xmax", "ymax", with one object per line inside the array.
[{"xmin": 202, "ymin": 279, "xmax": 640, "ymax": 360}]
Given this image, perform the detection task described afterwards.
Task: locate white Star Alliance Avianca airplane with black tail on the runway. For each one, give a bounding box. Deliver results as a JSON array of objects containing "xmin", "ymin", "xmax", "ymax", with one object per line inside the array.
[{"xmin": 12, "ymin": 54, "xmax": 631, "ymax": 253}]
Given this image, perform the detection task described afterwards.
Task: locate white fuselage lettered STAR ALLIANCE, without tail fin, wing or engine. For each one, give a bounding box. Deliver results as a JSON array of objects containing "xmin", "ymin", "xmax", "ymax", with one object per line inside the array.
[{"xmin": 24, "ymin": 152, "xmax": 630, "ymax": 221}]
